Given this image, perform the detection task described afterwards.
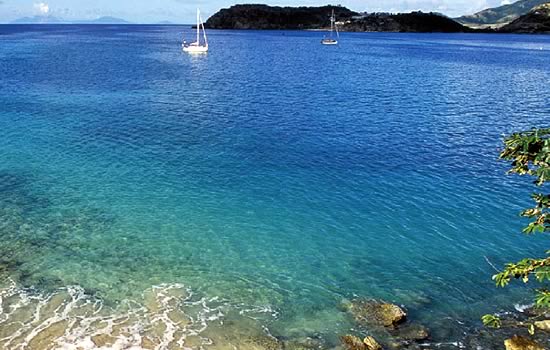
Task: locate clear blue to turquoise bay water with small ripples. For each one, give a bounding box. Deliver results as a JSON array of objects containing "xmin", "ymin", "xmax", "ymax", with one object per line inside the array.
[{"xmin": 0, "ymin": 26, "xmax": 550, "ymax": 348}]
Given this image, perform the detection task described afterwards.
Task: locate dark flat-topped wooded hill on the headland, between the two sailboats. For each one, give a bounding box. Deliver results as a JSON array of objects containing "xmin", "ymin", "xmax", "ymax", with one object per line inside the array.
[{"xmin": 205, "ymin": 5, "xmax": 359, "ymax": 29}]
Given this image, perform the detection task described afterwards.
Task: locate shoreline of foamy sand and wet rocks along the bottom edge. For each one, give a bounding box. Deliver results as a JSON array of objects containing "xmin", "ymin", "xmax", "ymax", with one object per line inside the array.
[{"xmin": 0, "ymin": 281, "xmax": 548, "ymax": 350}]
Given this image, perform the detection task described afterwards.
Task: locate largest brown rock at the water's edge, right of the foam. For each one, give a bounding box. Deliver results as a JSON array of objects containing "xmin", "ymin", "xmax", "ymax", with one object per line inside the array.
[{"xmin": 350, "ymin": 300, "xmax": 407, "ymax": 327}]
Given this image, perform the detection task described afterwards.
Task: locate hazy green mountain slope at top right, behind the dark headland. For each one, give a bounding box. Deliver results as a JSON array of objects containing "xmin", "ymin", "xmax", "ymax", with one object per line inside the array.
[{"xmin": 455, "ymin": 0, "xmax": 548, "ymax": 28}]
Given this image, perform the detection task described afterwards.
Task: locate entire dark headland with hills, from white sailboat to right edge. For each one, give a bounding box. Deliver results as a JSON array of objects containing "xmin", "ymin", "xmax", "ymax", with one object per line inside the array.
[{"xmin": 205, "ymin": 0, "xmax": 550, "ymax": 33}]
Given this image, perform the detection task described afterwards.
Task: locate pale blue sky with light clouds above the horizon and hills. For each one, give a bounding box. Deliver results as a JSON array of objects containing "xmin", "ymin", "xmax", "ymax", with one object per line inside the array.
[{"xmin": 0, "ymin": 0, "xmax": 510, "ymax": 23}]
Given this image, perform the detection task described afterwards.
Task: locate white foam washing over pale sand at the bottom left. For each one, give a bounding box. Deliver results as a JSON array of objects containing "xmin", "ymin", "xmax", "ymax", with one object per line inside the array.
[{"xmin": 0, "ymin": 281, "xmax": 275, "ymax": 350}]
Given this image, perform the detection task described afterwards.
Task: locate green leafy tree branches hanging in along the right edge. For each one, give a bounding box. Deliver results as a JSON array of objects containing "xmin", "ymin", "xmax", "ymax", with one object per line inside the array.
[{"xmin": 482, "ymin": 128, "xmax": 550, "ymax": 333}]
